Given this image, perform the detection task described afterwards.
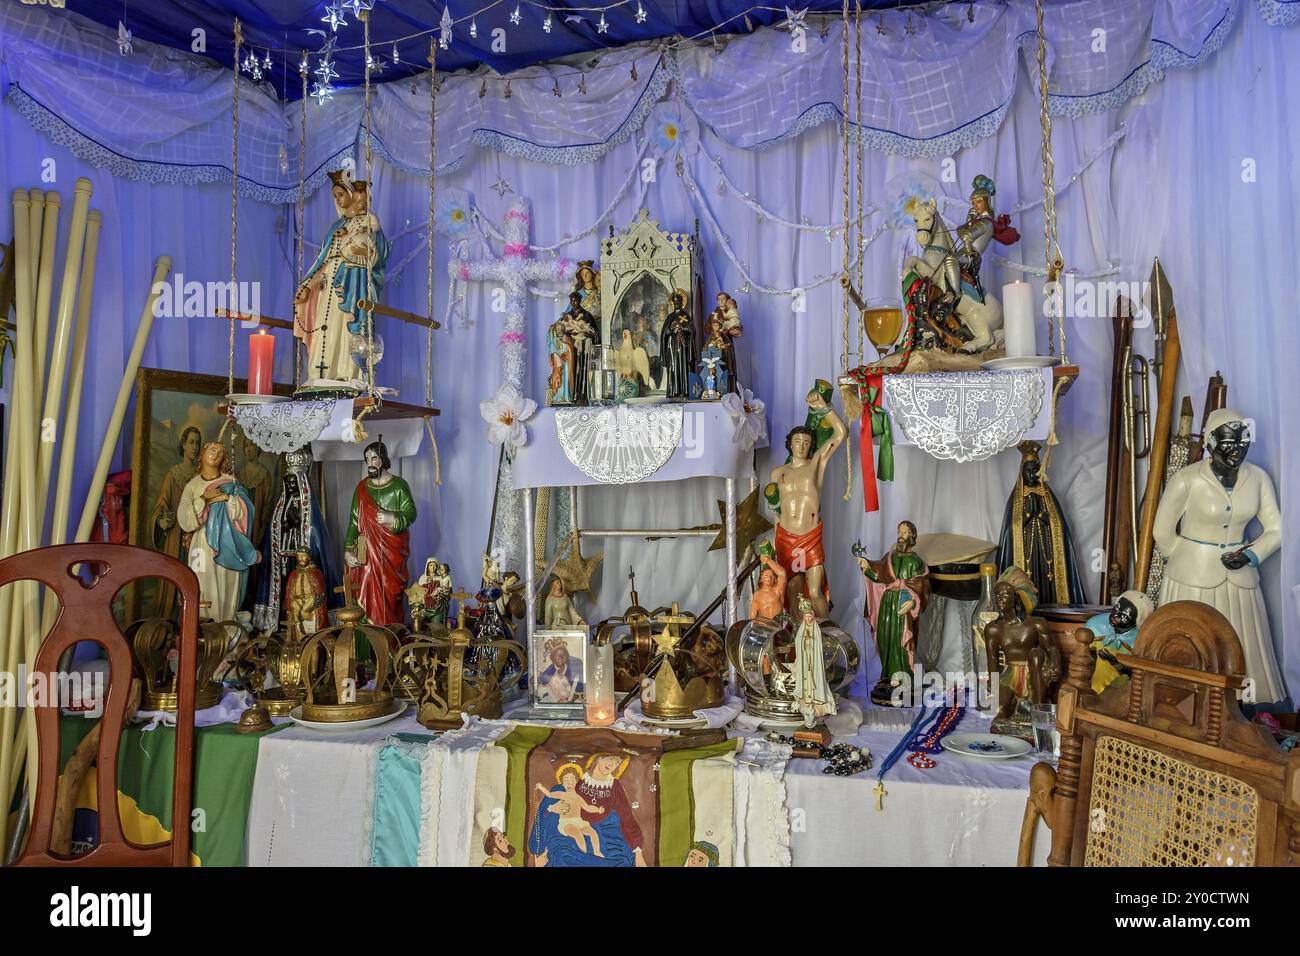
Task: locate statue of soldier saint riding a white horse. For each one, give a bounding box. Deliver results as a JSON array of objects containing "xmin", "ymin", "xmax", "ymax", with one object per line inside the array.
[{"xmin": 902, "ymin": 176, "xmax": 1021, "ymax": 352}]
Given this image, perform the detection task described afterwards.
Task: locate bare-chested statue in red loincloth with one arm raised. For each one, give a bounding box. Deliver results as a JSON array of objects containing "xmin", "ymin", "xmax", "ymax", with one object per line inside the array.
[{"xmin": 766, "ymin": 389, "xmax": 846, "ymax": 619}]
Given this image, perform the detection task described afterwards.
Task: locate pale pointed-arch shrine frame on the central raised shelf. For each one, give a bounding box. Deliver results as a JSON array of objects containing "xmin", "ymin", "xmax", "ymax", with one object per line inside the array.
[{"xmin": 599, "ymin": 209, "xmax": 702, "ymax": 397}]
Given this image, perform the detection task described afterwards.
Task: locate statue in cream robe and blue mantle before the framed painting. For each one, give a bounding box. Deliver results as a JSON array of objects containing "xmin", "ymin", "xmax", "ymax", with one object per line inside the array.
[{"xmin": 176, "ymin": 441, "xmax": 261, "ymax": 620}]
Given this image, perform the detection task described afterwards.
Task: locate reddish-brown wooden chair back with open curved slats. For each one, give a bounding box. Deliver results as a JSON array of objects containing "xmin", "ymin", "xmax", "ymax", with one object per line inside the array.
[{"xmin": 0, "ymin": 544, "xmax": 199, "ymax": 866}]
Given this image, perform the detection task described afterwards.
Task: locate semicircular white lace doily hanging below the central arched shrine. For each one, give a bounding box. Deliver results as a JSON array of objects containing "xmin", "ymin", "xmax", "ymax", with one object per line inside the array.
[{"xmin": 555, "ymin": 405, "xmax": 683, "ymax": 485}]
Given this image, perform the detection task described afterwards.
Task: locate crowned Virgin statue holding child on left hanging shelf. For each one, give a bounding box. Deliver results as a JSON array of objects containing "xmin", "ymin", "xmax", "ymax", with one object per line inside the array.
[{"xmin": 294, "ymin": 170, "xmax": 389, "ymax": 385}]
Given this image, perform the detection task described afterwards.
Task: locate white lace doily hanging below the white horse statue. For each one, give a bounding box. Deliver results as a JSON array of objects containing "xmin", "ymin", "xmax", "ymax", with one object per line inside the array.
[{"xmin": 884, "ymin": 368, "xmax": 1043, "ymax": 462}]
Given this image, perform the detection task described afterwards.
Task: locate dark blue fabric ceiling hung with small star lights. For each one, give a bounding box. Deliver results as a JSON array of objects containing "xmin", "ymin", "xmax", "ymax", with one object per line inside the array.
[{"xmin": 68, "ymin": 0, "xmax": 920, "ymax": 100}]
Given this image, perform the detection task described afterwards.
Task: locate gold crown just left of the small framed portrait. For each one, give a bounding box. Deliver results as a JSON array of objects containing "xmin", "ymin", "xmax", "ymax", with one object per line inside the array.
[{"xmin": 393, "ymin": 591, "xmax": 528, "ymax": 730}]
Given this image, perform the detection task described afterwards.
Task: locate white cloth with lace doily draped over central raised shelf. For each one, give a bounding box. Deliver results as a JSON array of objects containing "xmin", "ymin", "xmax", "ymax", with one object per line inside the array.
[{"xmin": 512, "ymin": 402, "xmax": 767, "ymax": 489}]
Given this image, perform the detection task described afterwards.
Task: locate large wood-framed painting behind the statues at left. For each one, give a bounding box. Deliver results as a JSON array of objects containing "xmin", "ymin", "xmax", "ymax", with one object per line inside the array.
[{"xmin": 126, "ymin": 368, "xmax": 291, "ymax": 623}]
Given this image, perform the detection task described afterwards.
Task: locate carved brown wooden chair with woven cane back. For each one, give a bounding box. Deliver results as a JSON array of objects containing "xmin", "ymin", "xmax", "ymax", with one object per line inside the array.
[{"xmin": 1018, "ymin": 601, "xmax": 1300, "ymax": 866}]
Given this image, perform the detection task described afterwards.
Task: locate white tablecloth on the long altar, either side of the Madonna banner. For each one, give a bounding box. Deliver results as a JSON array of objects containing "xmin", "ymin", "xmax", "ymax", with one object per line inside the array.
[{"xmin": 247, "ymin": 713, "xmax": 1050, "ymax": 866}]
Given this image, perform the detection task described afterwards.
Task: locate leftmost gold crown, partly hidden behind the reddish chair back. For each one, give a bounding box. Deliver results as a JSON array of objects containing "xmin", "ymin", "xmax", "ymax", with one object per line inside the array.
[{"xmin": 126, "ymin": 618, "xmax": 243, "ymax": 711}]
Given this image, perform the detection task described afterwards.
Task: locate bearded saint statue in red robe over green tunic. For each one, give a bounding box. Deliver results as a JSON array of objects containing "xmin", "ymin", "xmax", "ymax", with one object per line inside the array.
[{"xmin": 343, "ymin": 441, "xmax": 415, "ymax": 627}]
